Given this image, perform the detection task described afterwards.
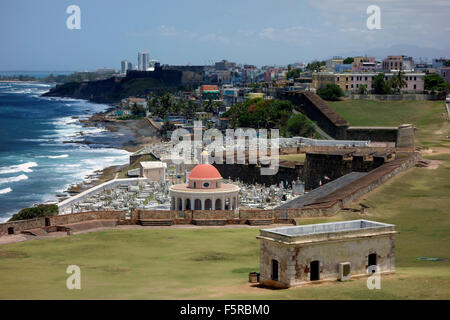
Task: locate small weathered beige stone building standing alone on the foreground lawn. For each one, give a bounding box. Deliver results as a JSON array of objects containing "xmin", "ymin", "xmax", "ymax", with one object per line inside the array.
[{"xmin": 257, "ymin": 220, "xmax": 397, "ymax": 287}]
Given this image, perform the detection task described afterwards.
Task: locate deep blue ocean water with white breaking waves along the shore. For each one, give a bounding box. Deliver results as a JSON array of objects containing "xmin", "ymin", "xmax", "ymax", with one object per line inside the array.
[{"xmin": 0, "ymin": 82, "xmax": 129, "ymax": 222}]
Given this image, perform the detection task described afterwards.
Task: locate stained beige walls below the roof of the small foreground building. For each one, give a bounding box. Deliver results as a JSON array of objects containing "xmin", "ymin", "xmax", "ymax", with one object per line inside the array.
[{"xmin": 260, "ymin": 233, "xmax": 395, "ymax": 286}]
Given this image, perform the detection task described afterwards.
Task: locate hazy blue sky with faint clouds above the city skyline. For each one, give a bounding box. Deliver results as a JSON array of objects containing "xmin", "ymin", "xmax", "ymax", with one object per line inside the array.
[{"xmin": 0, "ymin": 0, "xmax": 450, "ymax": 70}]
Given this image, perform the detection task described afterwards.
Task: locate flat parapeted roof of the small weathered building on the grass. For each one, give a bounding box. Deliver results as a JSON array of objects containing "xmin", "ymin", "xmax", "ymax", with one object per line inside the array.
[{"xmin": 257, "ymin": 219, "xmax": 397, "ymax": 243}]
